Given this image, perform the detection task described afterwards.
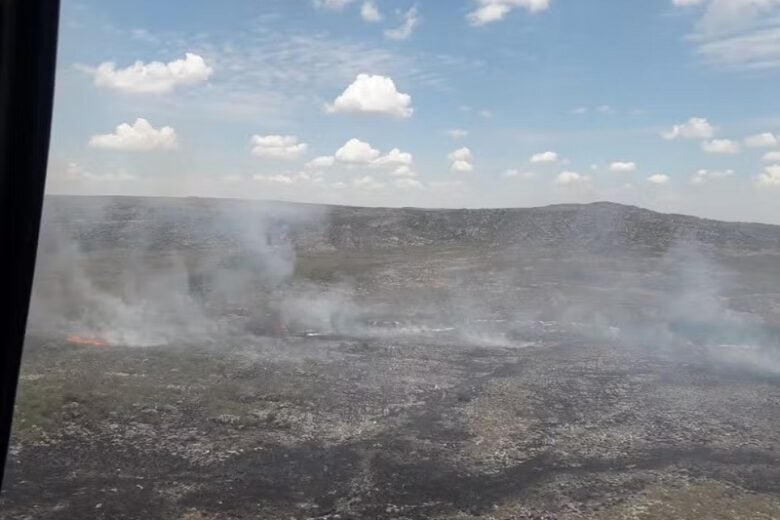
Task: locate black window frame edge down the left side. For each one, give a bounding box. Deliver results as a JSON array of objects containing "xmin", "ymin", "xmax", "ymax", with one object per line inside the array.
[{"xmin": 0, "ymin": 0, "xmax": 60, "ymax": 486}]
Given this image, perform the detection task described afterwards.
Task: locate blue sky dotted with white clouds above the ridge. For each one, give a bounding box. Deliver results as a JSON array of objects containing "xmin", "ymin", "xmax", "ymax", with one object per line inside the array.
[{"xmin": 47, "ymin": 0, "xmax": 780, "ymax": 224}]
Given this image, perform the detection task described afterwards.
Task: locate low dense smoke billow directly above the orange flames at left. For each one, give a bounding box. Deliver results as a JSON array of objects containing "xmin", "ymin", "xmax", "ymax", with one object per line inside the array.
[{"xmin": 29, "ymin": 230, "xmax": 218, "ymax": 346}]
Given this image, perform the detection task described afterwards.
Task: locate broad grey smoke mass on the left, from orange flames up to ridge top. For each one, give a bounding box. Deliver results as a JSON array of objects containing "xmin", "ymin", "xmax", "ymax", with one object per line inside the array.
[{"xmin": 28, "ymin": 199, "xmax": 332, "ymax": 346}]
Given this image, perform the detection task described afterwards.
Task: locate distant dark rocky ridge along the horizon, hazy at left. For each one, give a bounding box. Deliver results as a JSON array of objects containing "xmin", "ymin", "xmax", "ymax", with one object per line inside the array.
[{"xmin": 42, "ymin": 196, "xmax": 780, "ymax": 252}]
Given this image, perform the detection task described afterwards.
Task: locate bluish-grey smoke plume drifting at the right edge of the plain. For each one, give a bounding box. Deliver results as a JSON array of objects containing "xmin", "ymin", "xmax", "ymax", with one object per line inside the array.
[{"xmin": 541, "ymin": 236, "xmax": 780, "ymax": 372}]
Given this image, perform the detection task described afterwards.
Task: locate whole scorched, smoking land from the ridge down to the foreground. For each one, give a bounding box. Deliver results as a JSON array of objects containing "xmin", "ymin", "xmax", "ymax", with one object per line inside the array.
[{"xmin": 0, "ymin": 197, "xmax": 780, "ymax": 520}]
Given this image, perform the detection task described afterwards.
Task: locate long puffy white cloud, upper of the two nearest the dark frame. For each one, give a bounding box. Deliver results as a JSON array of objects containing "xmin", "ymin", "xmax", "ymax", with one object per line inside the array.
[{"xmin": 87, "ymin": 52, "xmax": 214, "ymax": 94}]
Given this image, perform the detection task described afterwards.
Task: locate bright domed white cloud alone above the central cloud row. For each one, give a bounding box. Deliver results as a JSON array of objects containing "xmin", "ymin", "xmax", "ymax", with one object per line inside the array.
[{"xmin": 325, "ymin": 74, "xmax": 414, "ymax": 118}]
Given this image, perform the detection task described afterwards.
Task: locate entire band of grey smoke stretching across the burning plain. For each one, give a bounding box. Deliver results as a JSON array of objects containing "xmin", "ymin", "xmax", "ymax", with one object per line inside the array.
[{"xmin": 25, "ymin": 195, "xmax": 780, "ymax": 371}]
